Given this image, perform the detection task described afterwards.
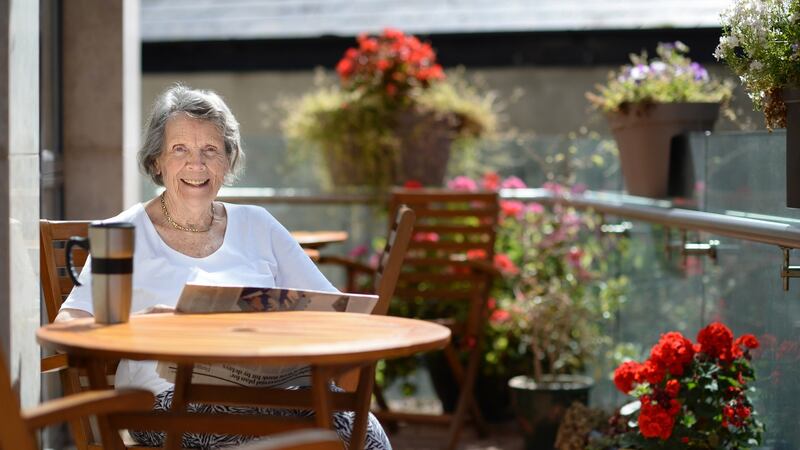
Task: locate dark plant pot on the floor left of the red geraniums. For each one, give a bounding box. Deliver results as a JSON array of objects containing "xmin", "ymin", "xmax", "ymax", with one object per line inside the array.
[{"xmin": 508, "ymin": 375, "xmax": 594, "ymax": 450}]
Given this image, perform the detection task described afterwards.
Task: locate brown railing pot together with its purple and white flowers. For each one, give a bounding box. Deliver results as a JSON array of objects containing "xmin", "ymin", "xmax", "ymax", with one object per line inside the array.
[{"xmin": 587, "ymin": 42, "xmax": 732, "ymax": 197}]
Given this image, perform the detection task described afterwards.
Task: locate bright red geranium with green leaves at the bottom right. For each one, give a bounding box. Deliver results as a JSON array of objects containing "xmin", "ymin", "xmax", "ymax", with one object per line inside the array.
[{"xmin": 614, "ymin": 322, "xmax": 764, "ymax": 449}]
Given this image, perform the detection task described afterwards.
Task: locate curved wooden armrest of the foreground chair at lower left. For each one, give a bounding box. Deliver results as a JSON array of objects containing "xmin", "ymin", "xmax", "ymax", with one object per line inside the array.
[{"xmin": 22, "ymin": 389, "xmax": 155, "ymax": 430}]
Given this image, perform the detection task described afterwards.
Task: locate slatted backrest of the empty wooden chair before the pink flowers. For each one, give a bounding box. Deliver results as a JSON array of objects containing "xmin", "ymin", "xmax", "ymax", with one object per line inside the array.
[{"xmin": 390, "ymin": 189, "xmax": 500, "ymax": 342}]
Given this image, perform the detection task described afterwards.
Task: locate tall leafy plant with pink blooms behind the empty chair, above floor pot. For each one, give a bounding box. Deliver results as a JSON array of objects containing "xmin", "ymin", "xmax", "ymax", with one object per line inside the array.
[{"xmin": 449, "ymin": 172, "xmax": 628, "ymax": 379}]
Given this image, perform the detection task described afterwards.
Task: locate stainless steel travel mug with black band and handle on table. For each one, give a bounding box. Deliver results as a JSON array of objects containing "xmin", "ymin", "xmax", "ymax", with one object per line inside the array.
[{"xmin": 65, "ymin": 222, "xmax": 135, "ymax": 324}]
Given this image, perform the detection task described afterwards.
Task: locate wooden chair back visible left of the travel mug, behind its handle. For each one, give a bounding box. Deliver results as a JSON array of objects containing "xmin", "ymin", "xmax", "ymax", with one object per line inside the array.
[{"xmin": 39, "ymin": 219, "xmax": 90, "ymax": 323}]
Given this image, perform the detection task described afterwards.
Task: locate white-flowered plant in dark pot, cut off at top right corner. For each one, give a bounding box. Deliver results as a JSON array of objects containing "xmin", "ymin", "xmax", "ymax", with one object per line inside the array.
[{"xmin": 714, "ymin": 0, "xmax": 800, "ymax": 208}]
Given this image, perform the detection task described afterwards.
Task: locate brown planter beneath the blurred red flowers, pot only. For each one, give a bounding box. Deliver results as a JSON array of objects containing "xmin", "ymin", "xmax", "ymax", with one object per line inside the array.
[{"xmin": 325, "ymin": 111, "xmax": 461, "ymax": 188}]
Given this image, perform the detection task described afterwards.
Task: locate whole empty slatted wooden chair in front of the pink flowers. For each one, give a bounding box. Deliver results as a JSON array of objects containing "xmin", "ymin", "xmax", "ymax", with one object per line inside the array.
[{"xmin": 376, "ymin": 189, "xmax": 499, "ymax": 449}]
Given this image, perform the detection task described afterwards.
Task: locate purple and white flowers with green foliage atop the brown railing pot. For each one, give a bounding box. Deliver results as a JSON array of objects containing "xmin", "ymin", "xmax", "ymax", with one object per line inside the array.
[{"xmin": 586, "ymin": 41, "xmax": 732, "ymax": 112}]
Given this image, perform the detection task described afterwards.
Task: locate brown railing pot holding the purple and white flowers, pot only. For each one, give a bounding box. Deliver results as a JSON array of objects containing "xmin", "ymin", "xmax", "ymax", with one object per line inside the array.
[{"xmin": 606, "ymin": 103, "xmax": 719, "ymax": 198}]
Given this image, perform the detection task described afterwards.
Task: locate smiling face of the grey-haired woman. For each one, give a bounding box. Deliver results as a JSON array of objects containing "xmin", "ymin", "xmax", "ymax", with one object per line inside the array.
[{"xmin": 156, "ymin": 114, "xmax": 230, "ymax": 206}]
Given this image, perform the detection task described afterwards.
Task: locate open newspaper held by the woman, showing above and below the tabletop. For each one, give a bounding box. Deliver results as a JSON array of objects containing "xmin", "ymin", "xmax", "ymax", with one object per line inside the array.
[{"xmin": 156, "ymin": 283, "xmax": 378, "ymax": 388}]
